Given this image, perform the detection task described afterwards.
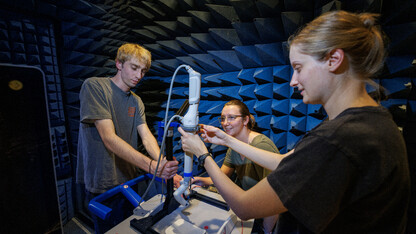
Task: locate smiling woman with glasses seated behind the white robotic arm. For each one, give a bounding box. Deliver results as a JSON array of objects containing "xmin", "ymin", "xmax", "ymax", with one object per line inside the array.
[{"xmin": 175, "ymin": 100, "xmax": 279, "ymax": 233}]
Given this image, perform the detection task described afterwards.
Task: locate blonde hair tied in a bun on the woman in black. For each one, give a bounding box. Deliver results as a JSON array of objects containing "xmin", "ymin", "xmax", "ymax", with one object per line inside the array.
[{"xmin": 289, "ymin": 11, "xmax": 386, "ymax": 83}]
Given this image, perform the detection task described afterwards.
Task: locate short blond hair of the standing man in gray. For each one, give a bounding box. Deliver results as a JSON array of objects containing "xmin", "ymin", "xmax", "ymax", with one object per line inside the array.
[{"xmin": 116, "ymin": 43, "xmax": 152, "ymax": 70}]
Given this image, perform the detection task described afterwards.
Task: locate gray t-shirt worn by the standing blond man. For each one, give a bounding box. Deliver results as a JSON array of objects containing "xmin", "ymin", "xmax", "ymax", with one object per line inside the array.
[{"xmin": 76, "ymin": 77, "xmax": 146, "ymax": 193}]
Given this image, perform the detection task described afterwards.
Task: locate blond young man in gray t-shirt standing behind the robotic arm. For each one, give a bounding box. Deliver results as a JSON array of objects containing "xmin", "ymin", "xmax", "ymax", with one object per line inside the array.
[{"xmin": 77, "ymin": 43, "xmax": 178, "ymax": 203}]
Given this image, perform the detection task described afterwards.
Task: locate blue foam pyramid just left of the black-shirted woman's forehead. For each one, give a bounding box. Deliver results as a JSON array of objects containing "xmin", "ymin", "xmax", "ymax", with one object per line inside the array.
[{"xmin": 254, "ymin": 42, "xmax": 286, "ymax": 66}]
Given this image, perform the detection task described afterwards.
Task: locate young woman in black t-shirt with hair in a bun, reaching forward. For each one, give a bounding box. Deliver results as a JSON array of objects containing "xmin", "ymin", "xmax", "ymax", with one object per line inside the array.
[{"xmin": 179, "ymin": 11, "xmax": 410, "ymax": 233}]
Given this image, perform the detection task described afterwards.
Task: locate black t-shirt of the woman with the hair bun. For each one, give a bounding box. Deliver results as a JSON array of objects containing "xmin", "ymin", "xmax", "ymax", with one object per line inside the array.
[{"xmin": 267, "ymin": 107, "xmax": 410, "ymax": 233}]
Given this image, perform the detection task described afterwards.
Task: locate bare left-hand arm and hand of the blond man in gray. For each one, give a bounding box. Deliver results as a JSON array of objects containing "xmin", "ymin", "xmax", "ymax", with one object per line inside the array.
[{"xmin": 94, "ymin": 119, "xmax": 178, "ymax": 179}]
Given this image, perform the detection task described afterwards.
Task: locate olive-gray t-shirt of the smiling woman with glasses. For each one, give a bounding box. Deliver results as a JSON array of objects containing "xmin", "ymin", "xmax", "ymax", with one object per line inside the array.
[{"xmin": 224, "ymin": 134, "xmax": 279, "ymax": 190}]
